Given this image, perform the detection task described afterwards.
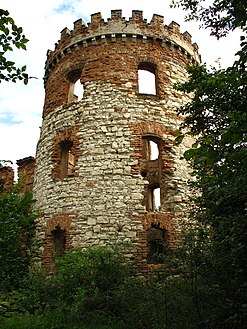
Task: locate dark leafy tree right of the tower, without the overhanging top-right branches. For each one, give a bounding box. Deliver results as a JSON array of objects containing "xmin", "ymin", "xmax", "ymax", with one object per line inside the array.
[{"xmin": 177, "ymin": 66, "xmax": 247, "ymax": 329}]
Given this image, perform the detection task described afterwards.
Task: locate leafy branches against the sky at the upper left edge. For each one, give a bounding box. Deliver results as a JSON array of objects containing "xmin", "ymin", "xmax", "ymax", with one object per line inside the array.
[{"xmin": 0, "ymin": 9, "xmax": 29, "ymax": 84}]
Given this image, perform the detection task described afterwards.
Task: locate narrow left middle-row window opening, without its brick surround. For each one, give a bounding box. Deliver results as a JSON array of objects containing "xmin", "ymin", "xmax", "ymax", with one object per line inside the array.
[{"xmin": 60, "ymin": 140, "xmax": 75, "ymax": 179}]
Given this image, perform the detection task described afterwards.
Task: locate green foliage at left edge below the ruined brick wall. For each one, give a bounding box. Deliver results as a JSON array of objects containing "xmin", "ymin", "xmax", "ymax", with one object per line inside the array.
[{"xmin": 0, "ymin": 186, "xmax": 35, "ymax": 291}]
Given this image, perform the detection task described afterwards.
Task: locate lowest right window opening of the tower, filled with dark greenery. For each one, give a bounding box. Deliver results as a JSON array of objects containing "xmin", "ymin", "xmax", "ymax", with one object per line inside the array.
[{"xmin": 147, "ymin": 227, "xmax": 166, "ymax": 264}]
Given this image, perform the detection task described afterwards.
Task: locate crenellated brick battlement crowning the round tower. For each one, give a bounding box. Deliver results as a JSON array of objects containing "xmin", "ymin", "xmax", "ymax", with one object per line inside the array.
[{"xmin": 45, "ymin": 9, "xmax": 200, "ymax": 70}]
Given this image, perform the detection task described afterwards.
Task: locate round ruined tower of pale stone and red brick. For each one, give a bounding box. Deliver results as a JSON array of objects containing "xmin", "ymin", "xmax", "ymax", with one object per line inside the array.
[{"xmin": 33, "ymin": 10, "xmax": 200, "ymax": 271}]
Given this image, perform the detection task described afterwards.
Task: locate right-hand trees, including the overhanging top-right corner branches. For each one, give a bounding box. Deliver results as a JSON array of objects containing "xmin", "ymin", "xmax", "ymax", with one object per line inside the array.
[{"xmin": 174, "ymin": 0, "xmax": 247, "ymax": 329}]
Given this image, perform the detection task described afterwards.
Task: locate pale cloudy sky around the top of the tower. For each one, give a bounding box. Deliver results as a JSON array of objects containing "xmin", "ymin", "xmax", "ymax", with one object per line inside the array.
[{"xmin": 0, "ymin": 0, "xmax": 240, "ymax": 174}]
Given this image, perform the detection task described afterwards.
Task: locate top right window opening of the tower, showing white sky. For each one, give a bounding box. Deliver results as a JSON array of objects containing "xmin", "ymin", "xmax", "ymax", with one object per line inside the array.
[{"xmin": 138, "ymin": 63, "xmax": 157, "ymax": 95}]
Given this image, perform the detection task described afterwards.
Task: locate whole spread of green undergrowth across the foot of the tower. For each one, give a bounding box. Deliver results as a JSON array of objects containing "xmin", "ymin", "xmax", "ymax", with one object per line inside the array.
[{"xmin": 0, "ymin": 247, "xmax": 201, "ymax": 329}]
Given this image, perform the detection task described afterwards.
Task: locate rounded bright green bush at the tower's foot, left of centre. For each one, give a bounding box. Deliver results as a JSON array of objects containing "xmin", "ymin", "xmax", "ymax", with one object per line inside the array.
[{"xmin": 24, "ymin": 247, "xmax": 133, "ymax": 323}]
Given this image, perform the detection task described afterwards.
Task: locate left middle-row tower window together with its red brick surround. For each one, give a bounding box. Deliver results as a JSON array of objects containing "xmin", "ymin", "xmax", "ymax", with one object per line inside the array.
[{"xmin": 51, "ymin": 126, "xmax": 82, "ymax": 180}]
